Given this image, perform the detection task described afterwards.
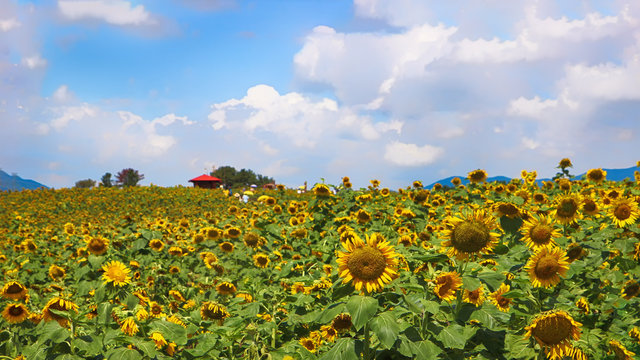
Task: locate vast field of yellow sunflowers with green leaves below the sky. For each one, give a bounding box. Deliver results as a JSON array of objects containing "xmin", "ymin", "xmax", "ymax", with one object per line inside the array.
[{"xmin": 0, "ymin": 165, "xmax": 640, "ymax": 360}]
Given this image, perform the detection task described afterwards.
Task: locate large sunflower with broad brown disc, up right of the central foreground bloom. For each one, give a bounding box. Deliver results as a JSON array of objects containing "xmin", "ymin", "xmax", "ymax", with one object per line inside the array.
[{"xmin": 442, "ymin": 210, "xmax": 499, "ymax": 260}]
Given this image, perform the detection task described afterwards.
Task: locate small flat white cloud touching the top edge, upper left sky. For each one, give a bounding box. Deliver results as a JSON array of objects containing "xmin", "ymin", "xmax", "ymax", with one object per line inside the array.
[{"xmin": 58, "ymin": 0, "xmax": 155, "ymax": 26}]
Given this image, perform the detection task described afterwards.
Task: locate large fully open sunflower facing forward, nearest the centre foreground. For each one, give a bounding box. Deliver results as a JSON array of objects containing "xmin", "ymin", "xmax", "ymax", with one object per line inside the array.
[{"xmin": 337, "ymin": 234, "xmax": 398, "ymax": 293}]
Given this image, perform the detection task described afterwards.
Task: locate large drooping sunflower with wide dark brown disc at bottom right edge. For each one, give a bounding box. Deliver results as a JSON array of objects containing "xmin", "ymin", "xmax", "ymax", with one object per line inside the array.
[{"xmin": 525, "ymin": 310, "xmax": 582, "ymax": 360}]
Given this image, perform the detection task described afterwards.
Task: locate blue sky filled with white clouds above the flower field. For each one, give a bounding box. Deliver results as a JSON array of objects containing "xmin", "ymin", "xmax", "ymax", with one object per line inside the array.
[{"xmin": 0, "ymin": 0, "xmax": 640, "ymax": 189}]
